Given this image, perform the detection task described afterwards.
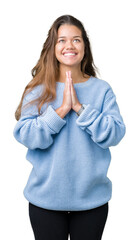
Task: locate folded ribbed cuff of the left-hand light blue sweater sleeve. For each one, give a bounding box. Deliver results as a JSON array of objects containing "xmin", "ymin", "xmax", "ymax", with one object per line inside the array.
[{"xmin": 40, "ymin": 105, "xmax": 66, "ymax": 133}]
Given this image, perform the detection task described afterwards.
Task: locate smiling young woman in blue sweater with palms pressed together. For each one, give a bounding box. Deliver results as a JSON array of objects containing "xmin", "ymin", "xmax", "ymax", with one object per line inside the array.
[{"xmin": 13, "ymin": 15, "xmax": 125, "ymax": 240}]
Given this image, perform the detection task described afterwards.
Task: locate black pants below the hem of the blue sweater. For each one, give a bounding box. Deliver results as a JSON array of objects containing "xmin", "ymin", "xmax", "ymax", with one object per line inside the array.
[{"xmin": 29, "ymin": 202, "xmax": 108, "ymax": 240}]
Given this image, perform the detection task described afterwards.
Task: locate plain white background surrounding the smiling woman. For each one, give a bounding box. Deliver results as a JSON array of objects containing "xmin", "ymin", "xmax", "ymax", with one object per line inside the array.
[{"xmin": 0, "ymin": 0, "xmax": 139, "ymax": 240}]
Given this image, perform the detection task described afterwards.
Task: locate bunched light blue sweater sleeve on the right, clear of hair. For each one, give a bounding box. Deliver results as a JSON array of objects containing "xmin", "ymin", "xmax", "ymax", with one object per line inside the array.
[{"xmin": 76, "ymin": 88, "xmax": 126, "ymax": 149}]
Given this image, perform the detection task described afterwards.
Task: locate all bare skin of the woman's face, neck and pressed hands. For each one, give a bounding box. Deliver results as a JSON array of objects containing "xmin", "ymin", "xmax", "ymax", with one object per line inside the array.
[{"xmin": 55, "ymin": 24, "xmax": 90, "ymax": 117}]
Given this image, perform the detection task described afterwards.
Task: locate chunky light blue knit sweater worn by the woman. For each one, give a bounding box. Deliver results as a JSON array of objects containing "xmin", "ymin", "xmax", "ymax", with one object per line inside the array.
[{"xmin": 13, "ymin": 76, "xmax": 126, "ymax": 211}]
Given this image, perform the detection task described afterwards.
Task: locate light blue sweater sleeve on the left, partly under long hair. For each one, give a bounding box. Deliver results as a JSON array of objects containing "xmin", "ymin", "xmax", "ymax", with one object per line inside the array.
[{"xmin": 13, "ymin": 92, "xmax": 66, "ymax": 149}]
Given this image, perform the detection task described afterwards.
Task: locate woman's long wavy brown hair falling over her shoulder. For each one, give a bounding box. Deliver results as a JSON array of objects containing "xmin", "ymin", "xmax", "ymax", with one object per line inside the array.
[{"xmin": 15, "ymin": 15, "xmax": 99, "ymax": 120}]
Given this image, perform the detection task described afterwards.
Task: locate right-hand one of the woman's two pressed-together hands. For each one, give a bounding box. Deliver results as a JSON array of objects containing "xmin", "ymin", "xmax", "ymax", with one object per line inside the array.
[{"xmin": 66, "ymin": 71, "xmax": 81, "ymax": 112}]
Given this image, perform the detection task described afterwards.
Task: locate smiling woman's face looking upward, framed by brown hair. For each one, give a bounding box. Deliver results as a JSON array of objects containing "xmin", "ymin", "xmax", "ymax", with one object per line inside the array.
[{"xmin": 55, "ymin": 24, "xmax": 84, "ymax": 66}]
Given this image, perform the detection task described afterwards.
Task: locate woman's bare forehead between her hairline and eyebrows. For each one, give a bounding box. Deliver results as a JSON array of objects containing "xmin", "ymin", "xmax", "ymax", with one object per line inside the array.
[{"xmin": 57, "ymin": 24, "xmax": 82, "ymax": 37}]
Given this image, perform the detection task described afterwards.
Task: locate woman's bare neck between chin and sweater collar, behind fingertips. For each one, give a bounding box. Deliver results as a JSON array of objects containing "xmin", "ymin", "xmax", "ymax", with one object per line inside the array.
[{"xmin": 58, "ymin": 65, "xmax": 83, "ymax": 83}]
